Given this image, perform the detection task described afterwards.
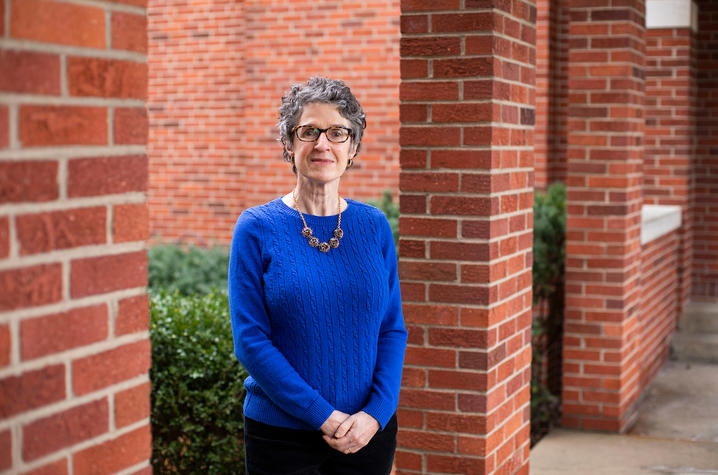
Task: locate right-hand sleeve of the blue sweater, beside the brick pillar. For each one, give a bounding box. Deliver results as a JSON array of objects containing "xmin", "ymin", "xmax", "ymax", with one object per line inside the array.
[{"xmin": 362, "ymin": 215, "xmax": 408, "ymax": 429}]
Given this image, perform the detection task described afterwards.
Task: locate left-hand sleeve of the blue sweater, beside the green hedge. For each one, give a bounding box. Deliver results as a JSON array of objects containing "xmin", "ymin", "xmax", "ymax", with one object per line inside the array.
[{"xmin": 228, "ymin": 211, "xmax": 334, "ymax": 429}]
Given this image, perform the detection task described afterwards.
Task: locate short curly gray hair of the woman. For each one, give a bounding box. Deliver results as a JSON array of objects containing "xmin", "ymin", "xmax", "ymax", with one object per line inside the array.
[{"xmin": 277, "ymin": 77, "xmax": 366, "ymax": 167}]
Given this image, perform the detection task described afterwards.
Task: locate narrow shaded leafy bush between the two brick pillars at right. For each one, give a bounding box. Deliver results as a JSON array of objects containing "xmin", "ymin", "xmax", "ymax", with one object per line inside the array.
[{"xmin": 531, "ymin": 183, "xmax": 566, "ymax": 444}]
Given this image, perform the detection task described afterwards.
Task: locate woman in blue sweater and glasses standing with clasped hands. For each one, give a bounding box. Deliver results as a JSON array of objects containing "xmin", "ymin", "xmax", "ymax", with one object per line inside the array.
[{"xmin": 229, "ymin": 78, "xmax": 407, "ymax": 475}]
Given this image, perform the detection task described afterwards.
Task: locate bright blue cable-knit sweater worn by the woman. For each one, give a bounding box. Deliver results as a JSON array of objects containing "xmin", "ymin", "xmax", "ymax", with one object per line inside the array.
[{"xmin": 229, "ymin": 198, "xmax": 407, "ymax": 429}]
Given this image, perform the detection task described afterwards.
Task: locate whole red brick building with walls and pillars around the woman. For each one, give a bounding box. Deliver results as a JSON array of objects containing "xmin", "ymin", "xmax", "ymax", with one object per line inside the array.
[{"xmin": 0, "ymin": 0, "xmax": 718, "ymax": 474}]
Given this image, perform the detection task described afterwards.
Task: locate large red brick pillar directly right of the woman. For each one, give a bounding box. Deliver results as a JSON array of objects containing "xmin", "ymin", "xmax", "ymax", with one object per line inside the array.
[{"xmin": 397, "ymin": 0, "xmax": 536, "ymax": 474}]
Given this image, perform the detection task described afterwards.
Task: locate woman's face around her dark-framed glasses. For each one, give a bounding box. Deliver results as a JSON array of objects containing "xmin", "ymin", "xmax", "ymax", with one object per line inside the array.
[{"xmin": 287, "ymin": 103, "xmax": 356, "ymax": 184}]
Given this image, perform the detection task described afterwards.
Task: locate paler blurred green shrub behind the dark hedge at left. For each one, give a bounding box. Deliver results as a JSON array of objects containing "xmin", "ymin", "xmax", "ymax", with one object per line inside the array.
[{"xmin": 147, "ymin": 244, "xmax": 229, "ymax": 295}]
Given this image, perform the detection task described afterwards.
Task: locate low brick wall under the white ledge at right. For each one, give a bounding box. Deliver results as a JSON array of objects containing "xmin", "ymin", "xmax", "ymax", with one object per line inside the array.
[{"xmin": 638, "ymin": 229, "xmax": 681, "ymax": 392}]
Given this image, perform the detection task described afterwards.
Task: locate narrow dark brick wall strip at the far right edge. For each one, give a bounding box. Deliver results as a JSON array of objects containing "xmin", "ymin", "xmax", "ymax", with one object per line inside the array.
[{"xmin": 692, "ymin": 0, "xmax": 718, "ymax": 300}]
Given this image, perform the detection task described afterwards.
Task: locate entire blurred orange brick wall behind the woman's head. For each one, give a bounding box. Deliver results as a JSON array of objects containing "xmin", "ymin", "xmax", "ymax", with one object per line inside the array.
[{"xmin": 149, "ymin": 0, "xmax": 399, "ymax": 243}]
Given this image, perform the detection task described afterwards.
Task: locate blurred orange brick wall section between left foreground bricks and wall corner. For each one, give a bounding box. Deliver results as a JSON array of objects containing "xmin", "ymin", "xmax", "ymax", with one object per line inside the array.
[{"xmin": 147, "ymin": 0, "xmax": 246, "ymax": 244}]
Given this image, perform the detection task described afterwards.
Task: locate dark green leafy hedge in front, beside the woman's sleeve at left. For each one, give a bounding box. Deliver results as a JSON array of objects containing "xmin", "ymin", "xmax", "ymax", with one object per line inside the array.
[{"xmin": 150, "ymin": 292, "xmax": 247, "ymax": 474}]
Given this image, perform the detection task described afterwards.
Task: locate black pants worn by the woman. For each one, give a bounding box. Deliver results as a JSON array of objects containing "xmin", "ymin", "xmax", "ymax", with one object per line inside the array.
[{"xmin": 244, "ymin": 415, "xmax": 397, "ymax": 475}]
